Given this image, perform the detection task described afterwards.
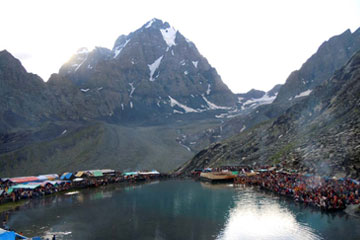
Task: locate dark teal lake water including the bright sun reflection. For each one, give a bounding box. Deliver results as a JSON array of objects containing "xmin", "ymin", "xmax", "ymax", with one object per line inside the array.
[{"xmin": 4, "ymin": 180, "xmax": 360, "ymax": 240}]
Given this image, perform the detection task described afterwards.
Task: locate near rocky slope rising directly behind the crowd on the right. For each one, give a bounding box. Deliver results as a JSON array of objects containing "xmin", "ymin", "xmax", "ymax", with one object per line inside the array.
[{"xmin": 180, "ymin": 51, "xmax": 360, "ymax": 178}]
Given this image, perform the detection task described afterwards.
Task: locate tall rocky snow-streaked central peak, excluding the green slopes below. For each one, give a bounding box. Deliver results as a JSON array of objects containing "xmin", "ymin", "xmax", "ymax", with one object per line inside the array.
[{"xmin": 59, "ymin": 19, "xmax": 237, "ymax": 122}]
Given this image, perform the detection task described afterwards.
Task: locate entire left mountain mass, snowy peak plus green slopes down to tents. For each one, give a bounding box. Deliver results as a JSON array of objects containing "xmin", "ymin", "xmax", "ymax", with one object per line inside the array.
[{"xmin": 0, "ymin": 19, "xmax": 237, "ymax": 176}]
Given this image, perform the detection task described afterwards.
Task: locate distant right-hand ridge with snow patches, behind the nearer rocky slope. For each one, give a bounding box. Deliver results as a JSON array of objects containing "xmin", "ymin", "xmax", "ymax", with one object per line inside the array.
[{"xmin": 183, "ymin": 28, "xmax": 360, "ymax": 144}]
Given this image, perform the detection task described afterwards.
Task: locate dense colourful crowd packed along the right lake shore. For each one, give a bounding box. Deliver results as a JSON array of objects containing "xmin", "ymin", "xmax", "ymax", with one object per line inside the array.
[{"xmin": 236, "ymin": 171, "xmax": 360, "ymax": 210}]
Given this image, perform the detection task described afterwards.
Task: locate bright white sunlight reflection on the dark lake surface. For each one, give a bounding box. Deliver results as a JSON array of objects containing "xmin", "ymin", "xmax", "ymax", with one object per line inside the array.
[{"xmin": 217, "ymin": 189, "xmax": 322, "ymax": 240}]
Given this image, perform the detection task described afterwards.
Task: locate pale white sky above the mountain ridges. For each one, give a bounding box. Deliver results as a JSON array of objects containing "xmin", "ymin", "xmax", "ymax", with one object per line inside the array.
[{"xmin": 0, "ymin": 0, "xmax": 360, "ymax": 93}]
